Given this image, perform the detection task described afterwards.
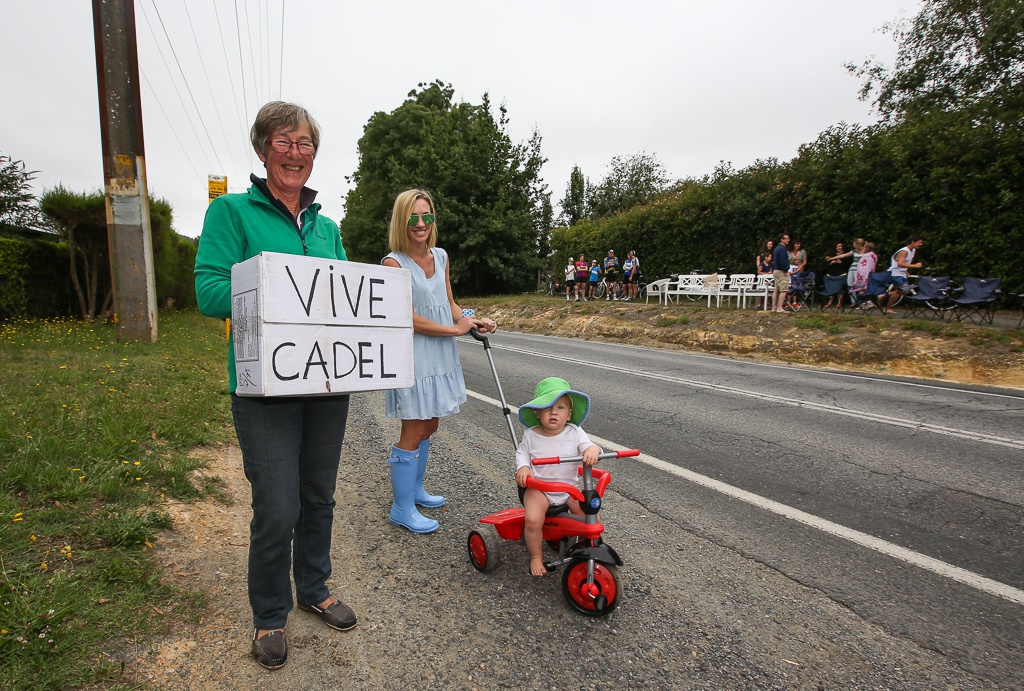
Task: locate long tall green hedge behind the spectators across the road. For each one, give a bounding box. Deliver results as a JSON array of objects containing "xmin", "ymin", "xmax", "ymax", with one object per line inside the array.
[{"xmin": 552, "ymin": 109, "xmax": 1024, "ymax": 291}]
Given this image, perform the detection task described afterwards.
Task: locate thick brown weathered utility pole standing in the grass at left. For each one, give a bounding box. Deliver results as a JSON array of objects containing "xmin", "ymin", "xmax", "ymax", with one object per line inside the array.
[{"xmin": 92, "ymin": 0, "xmax": 157, "ymax": 343}]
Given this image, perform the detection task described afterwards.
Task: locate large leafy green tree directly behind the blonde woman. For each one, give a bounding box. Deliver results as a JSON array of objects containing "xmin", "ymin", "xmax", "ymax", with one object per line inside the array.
[{"xmin": 341, "ymin": 81, "xmax": 550, "ymax": 295}]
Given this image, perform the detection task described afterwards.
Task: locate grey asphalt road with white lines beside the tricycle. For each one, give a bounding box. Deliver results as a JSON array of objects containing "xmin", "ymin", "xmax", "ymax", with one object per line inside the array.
[{"xmin": 459, "ymin": 333, "xmax": 1024, "ymax": 688}]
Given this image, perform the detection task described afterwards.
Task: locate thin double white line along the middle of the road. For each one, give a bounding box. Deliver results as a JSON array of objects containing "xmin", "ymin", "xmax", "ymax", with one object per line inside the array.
[{"xmin": 466, "ymin": 346, "xmax": 1024, "ymax": 449}]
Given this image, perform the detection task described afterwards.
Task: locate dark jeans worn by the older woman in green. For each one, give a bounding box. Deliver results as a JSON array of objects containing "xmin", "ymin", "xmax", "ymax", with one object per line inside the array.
[{"xmin": 231, "ymin": 394, "xmax": 348, "ymax": 629}]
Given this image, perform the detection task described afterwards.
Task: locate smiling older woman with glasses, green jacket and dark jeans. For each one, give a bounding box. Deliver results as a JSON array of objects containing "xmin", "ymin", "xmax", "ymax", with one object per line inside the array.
[{"xmin": 196, "ymin": 101, "xmax": 355, "ymax": 670}]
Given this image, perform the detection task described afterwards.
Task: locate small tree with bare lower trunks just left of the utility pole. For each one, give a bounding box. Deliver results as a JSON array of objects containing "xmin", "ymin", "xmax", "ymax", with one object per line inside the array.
[{"xmin": 39, "ymin": 184, "xmax": 114, "ymax": 318}]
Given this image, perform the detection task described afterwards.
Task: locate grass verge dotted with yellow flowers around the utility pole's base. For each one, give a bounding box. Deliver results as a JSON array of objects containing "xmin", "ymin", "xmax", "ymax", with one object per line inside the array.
[{"xmin": 0, "ymin": 312, "xmax": 232, "ymax": 689}]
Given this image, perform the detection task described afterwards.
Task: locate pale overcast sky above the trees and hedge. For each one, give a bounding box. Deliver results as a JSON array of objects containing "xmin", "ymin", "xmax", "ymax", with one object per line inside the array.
[{"xmin": 0, "ymin": 0, "xmax": 921, "ymax": 236}]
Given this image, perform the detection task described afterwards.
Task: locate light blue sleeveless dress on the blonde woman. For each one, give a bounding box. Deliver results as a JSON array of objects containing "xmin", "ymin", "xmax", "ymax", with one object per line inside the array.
[{"xmin": 384, "ymin": 247, "xmax": 466, "ymax": 420}]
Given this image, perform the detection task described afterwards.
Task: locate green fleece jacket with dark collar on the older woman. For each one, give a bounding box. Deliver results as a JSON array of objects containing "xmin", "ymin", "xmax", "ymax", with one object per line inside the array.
[{"xmin": 196, "ymin": 181, "xmax": 347, "ymax": 392}]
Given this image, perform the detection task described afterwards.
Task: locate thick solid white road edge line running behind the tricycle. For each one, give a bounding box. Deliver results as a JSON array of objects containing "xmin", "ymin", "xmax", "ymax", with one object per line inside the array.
[{"xmin": 466, "ymin": 391, "xmax": 1024, "ymax": 605}]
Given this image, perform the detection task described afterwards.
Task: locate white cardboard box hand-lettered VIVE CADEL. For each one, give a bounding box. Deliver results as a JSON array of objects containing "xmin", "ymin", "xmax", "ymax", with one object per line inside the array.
[{"xmin": 231, "ymin": 252, "xmax": 414, "ymax": 396}]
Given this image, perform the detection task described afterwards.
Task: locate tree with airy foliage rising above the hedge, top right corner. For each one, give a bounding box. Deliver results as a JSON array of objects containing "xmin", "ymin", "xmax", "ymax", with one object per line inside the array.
[{"xmin": 847, "ymin": 0, "xmax": 1024, "ymax": 124}]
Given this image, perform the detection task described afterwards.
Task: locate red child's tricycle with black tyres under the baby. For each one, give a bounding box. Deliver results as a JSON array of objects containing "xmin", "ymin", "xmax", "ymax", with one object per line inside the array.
[{"xmin": 467, "ymin": 448, "xmax": 640, "ymax": 616}]
